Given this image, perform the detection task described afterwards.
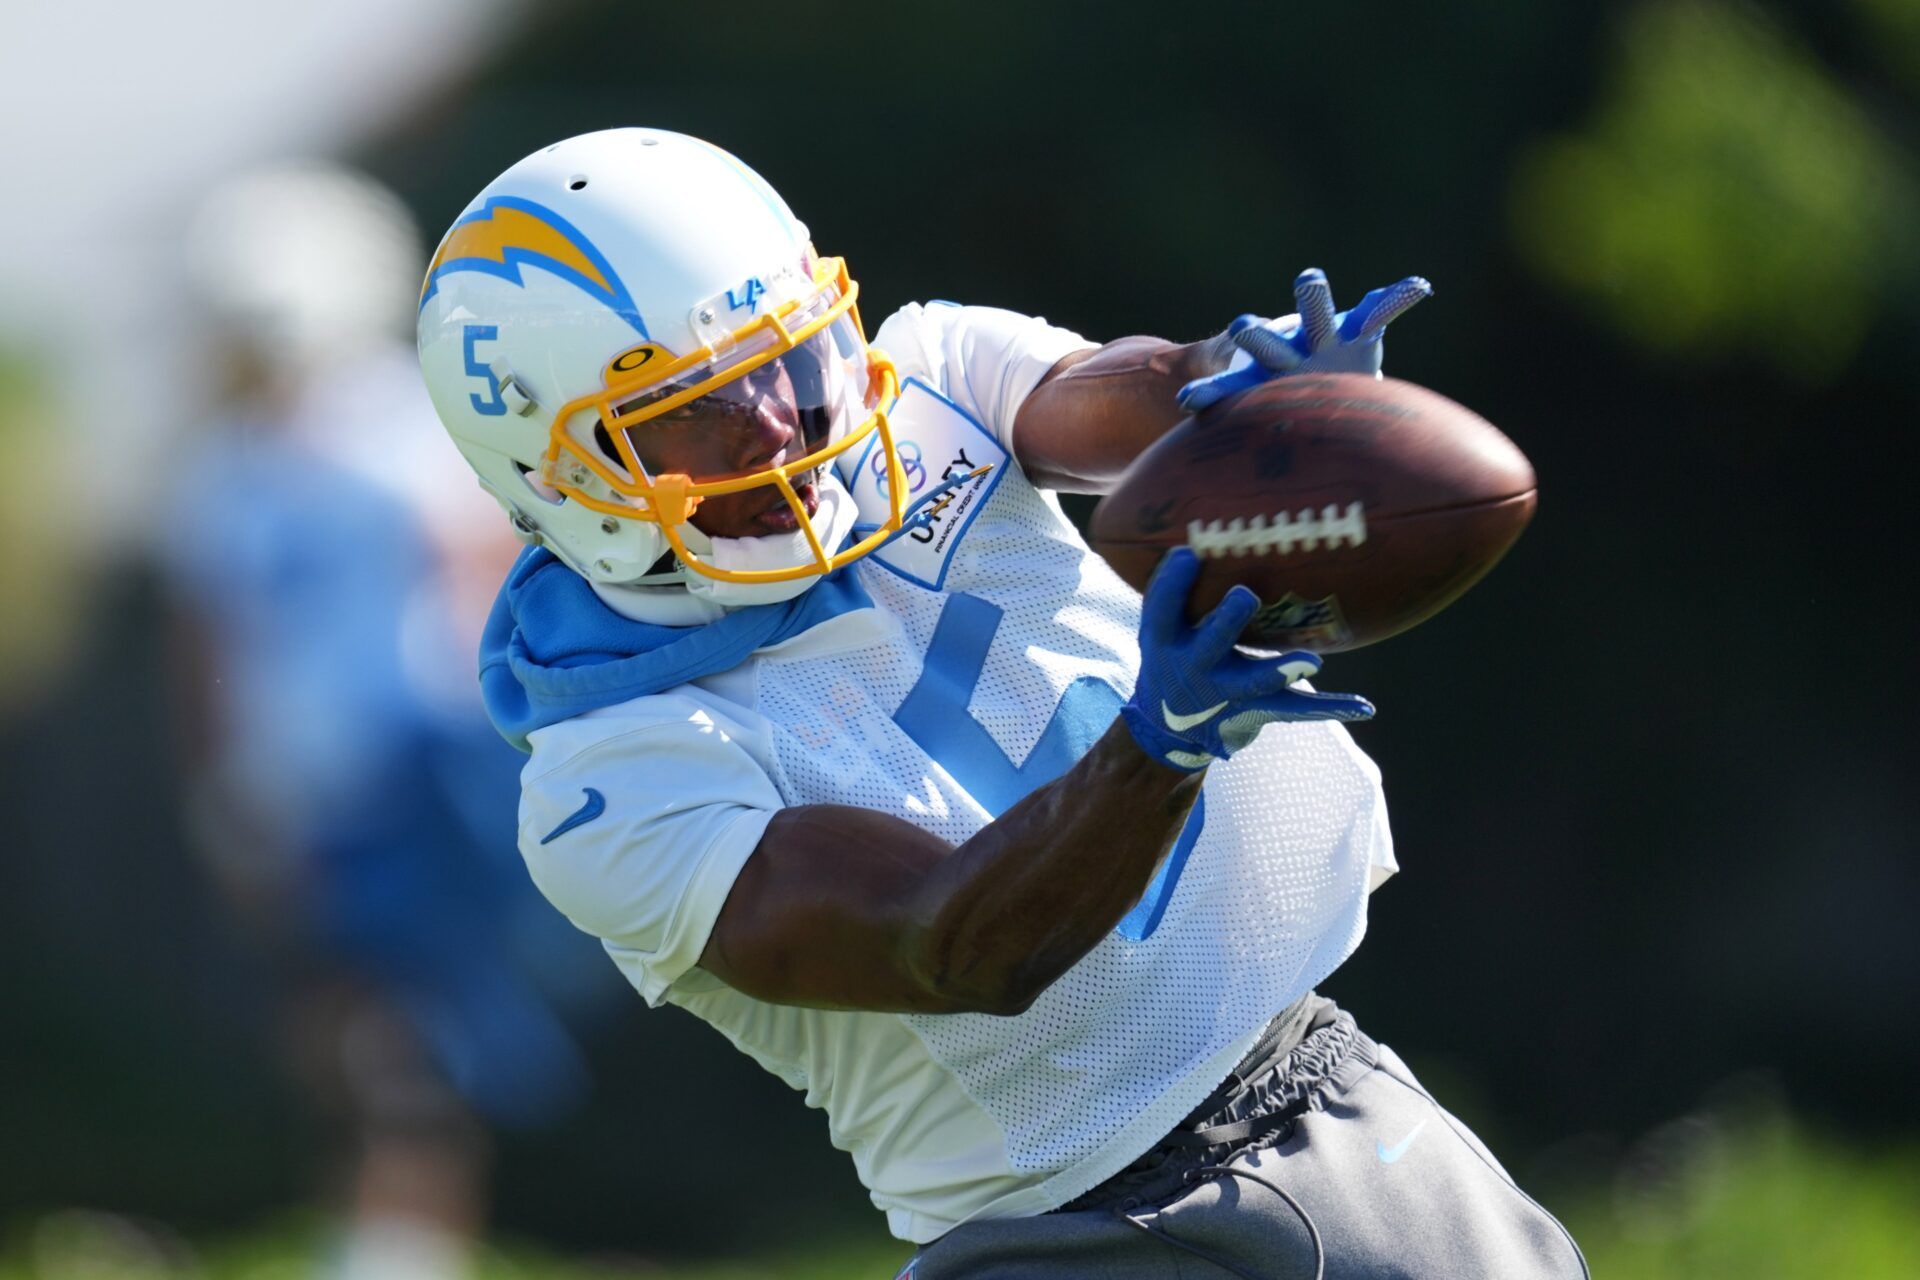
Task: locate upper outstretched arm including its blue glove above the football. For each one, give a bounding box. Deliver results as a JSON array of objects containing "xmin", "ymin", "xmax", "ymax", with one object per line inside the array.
[{"xmin": 1014, "ymin": 269, "xmax": 1432, "ymax": 493}]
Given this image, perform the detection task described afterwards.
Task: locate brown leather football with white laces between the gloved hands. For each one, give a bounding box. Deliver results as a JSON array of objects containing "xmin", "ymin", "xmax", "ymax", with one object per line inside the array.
[{"xmin": 1089, "ymin": 374, "xmax": 1536, "ymax": 652}]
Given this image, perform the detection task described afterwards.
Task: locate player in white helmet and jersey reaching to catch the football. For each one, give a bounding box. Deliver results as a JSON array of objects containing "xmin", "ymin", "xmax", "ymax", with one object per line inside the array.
[{"xmin": 419, "ymin": 129, "xmax": 1584, "ymax": 1280}]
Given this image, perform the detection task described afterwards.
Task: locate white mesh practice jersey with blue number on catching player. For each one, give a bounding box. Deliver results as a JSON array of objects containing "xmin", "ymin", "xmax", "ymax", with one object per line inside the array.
[{"xmin": 520, "ymin": 303, "xmax": 1394, "ymax": 1242}]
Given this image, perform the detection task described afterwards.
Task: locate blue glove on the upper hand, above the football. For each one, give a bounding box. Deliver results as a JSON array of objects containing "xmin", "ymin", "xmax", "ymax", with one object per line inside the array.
[{"xmin": 1179, "ymin": 267, "xmax": 1434, "ymax": 413}]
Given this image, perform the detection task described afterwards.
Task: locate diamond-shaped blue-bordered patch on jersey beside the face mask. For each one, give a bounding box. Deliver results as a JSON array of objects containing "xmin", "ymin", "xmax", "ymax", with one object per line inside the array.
[{"xmin": 839, "ymin": 378, "xmax": 1008, "ymax": 591}]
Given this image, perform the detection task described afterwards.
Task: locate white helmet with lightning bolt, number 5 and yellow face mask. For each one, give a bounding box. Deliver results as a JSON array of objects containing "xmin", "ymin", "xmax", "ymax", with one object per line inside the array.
[{"xmin": 419, "ymin": 129, "xmax": 906, "ymax": 604}]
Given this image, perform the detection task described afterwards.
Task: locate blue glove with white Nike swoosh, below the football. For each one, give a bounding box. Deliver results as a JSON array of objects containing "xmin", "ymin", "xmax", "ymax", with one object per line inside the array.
[{"xmin": 1119, "ymin": 547, "xmax": 1373, "ymax": 771}]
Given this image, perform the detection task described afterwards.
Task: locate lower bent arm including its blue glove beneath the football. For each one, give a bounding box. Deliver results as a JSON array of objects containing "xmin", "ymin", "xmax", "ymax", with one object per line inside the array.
[{"xmin": 701, "ymin": 549, "xmax": 1373, "ymax": 1013}]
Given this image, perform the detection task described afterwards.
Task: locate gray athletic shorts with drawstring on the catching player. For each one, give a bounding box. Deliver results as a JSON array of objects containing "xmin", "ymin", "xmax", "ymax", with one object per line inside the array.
[{"xmin": 900, "ymin": 1002, "xmax": 1588, "ymax": 1280}]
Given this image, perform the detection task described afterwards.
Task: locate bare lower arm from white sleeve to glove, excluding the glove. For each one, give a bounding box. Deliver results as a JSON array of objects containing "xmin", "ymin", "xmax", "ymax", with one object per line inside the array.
[{"xmin": 701, "ymin": 722, "xmax": 1200, "ymax": 1013}]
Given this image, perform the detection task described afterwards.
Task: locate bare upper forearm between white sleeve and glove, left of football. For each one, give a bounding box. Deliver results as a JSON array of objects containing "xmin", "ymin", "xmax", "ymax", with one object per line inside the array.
[{"xmin": 1014, "ymin": 334, "xmax": 1233, "ymax": 493}]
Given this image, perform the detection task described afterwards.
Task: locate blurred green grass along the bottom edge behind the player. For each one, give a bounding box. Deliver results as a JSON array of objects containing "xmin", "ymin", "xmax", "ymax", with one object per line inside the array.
[{"xmin": 0, "ymin": 1113, "xmax": 1920, "ymax": 1280}]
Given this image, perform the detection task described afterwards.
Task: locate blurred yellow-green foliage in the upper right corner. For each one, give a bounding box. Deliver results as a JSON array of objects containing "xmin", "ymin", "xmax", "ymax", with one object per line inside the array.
[{"xmin": 1513, "ymin": 0, "xmax": 1920, "ymax": 384}]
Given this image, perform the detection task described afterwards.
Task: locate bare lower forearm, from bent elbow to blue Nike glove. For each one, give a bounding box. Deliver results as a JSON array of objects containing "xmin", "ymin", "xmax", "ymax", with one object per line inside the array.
[{"xmin": 902, "ymin": 722, "xmax": 1202, "ymax": 1013}]
